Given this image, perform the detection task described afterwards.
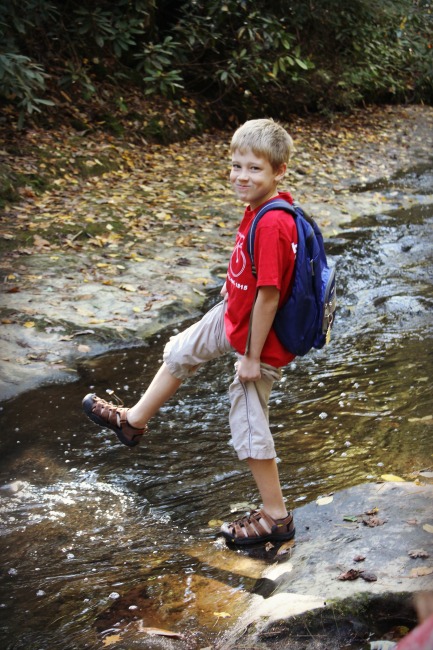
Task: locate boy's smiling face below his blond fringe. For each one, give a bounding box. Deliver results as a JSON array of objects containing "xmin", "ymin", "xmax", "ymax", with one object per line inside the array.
[{"xmin": 230, "ymin": 149, "xmax": 287, "ymax": 210}]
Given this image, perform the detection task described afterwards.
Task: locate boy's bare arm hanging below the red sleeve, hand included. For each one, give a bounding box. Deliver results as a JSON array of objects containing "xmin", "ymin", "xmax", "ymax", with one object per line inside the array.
[{"xmin": 236, "ymin": 287, "xmax": 280, "ymax": 382}]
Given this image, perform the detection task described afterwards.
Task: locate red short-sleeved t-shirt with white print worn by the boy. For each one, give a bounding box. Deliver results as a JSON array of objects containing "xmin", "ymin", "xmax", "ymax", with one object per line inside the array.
[{"xmin": 225, "ymin": 192, "xmax": 298, "ymax": 368}]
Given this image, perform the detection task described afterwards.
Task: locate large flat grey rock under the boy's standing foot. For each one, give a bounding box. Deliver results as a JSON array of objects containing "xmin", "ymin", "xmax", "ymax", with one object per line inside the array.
[{"xmin": 221, "ymin": 482, "xmax": 433, "ymax": 649}]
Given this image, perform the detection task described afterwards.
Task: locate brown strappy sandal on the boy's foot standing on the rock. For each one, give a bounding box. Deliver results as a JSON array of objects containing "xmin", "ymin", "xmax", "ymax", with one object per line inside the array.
[{"xmin": 221, "ymin": 510, "xmax": 295, "ymax": 545}]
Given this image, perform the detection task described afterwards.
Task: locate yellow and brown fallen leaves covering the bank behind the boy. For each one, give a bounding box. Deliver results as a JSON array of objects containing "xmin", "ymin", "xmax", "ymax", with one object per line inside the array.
[{"xmin": 0, "ymin": 107, "xmax": 433, "ymax": 384}]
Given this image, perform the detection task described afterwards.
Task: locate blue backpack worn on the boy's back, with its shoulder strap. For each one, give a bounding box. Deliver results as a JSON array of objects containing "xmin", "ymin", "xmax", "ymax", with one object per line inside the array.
[{"xmin": 247, "ymin": 199, "xmax": 336, "ymax": 356}]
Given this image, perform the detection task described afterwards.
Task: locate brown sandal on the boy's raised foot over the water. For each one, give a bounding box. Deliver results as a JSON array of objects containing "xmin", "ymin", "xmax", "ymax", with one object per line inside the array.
[{"xmin": 83, "ymin": 393, "xmax": 147, "ymax": 447}]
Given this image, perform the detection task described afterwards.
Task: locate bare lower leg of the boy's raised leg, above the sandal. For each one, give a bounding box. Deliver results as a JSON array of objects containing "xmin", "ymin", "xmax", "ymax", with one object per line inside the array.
[{"xmin": 128, "ymin": 363, "xmax": 182, "ymax": 429}]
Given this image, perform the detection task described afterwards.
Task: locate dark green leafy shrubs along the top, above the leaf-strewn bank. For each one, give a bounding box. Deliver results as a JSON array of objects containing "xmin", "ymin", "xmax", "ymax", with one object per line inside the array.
[{"xmin": 0, "ymin": 0, "xmax": 433, "ymax": 132}]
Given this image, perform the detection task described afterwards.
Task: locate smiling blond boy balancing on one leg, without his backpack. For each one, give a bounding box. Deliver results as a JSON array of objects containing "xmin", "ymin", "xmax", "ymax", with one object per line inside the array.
[{"xmin": 83, "ymin": 119, "xmax": 297, "ymax": 545}]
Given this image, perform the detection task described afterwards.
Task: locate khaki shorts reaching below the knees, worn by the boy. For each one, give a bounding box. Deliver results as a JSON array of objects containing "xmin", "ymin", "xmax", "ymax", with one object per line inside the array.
[{"xmin": 164, "ymin": 301, "xmax": 281, "ymax": 460}]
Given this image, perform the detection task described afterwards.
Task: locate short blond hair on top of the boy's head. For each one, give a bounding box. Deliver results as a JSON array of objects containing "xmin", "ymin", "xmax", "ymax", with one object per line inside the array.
[{"xmin": 230, "ymin": 119, "xmax": 293, "ymax": 170}]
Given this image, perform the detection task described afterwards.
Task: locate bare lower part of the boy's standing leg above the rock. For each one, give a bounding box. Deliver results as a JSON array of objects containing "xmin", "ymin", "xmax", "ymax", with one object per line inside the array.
[{"xmin": 247, "ymin": 458, "xmax": 287, "ymax": 519}]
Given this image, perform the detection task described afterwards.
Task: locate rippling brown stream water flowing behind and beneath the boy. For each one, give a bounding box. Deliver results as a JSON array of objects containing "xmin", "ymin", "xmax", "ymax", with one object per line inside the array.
[{"xmin": 0, "ymin": 165, "xmax": 433, "ymax": 650}]
